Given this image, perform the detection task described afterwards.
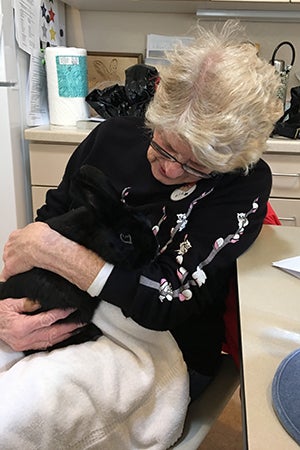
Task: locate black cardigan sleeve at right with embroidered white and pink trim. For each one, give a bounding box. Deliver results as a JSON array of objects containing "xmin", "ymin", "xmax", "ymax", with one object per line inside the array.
[{"xmin": 100, "ymin": 161, "xmax": 271, "ymax": 330}]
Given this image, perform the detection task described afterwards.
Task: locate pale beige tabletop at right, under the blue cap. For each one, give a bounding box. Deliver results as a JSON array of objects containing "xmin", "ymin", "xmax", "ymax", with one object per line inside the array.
[{"xmin": 237, "ymin": 225, "xmax": 300, "ymax": 450}]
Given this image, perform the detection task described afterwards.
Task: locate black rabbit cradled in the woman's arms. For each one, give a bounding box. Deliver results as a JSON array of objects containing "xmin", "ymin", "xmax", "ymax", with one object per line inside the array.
[{"xmin": 0, "ymin": 165, "xmax": 158, "ymax": 353}]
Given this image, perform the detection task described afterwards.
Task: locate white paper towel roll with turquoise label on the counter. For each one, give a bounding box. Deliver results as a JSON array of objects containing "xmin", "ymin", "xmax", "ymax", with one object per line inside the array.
[{"xmin": 45, "ymin": 47, "xmax": 88, "ymax": 126}]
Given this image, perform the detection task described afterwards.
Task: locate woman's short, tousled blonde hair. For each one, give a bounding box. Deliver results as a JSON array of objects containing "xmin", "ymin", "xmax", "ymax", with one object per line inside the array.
[{"xmin": 146, "ymin": 21, "xmax": 282, "ymax": 172}]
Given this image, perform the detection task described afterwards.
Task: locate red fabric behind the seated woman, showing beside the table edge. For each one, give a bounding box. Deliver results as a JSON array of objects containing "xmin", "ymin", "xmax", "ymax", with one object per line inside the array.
[{"xmin": 222, "ymin": 202, "xmax": 281, "ymax": 369}]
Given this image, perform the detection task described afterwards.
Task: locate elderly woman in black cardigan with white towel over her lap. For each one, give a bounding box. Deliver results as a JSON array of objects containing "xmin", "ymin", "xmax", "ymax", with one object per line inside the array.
[{"xmin": 0, "ymin": 22, "xmax": 281, "ymax": 449}]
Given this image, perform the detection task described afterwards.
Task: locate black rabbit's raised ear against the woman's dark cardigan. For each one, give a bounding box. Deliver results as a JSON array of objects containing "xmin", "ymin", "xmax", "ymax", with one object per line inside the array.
[{"xmin": 70, "ymin": 165, "xmax": 121, "ymax": 212}]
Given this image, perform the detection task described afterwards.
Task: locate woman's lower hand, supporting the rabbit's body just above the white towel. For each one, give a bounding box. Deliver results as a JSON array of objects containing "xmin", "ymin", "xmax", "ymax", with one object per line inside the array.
[{"xmin": 0, "ymin": 298, "xmax": 83, "ymax": 351}]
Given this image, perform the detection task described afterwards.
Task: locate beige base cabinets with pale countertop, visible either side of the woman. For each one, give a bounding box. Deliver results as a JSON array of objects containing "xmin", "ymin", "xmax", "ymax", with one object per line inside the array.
[{"xmin": 25, "ymin": 125, "xmax": 300, "ymax": 226}]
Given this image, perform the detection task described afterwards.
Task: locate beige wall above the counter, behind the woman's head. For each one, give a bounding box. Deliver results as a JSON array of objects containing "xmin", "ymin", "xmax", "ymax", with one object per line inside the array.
[{"xmin": 66, "ymin": 7, "xmax": 300, "ymax": 94}]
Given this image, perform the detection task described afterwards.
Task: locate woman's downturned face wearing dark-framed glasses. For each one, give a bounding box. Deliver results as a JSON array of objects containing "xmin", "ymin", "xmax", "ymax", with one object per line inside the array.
[{"xmin": 147, "ymin": 131, "xmax": 210, "ymax": 185}]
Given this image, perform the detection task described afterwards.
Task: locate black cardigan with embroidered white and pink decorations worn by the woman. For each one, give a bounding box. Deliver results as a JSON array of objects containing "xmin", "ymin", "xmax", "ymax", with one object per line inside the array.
[{"xmin": 37, "ymin": 117, "xmax": 271, "ymax": 375}]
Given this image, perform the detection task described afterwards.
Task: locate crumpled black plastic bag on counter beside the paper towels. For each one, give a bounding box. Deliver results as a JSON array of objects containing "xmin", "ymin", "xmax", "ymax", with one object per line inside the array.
[{"xmin": 85, "ymin": 64, "xmax": 159, "ymax": 119}]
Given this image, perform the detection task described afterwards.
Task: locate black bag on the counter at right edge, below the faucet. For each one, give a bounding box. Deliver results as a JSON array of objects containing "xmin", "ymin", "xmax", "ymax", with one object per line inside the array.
[{"xmin": 271, "ymin": 86, "xmax": 300, "ymax": 139}]
